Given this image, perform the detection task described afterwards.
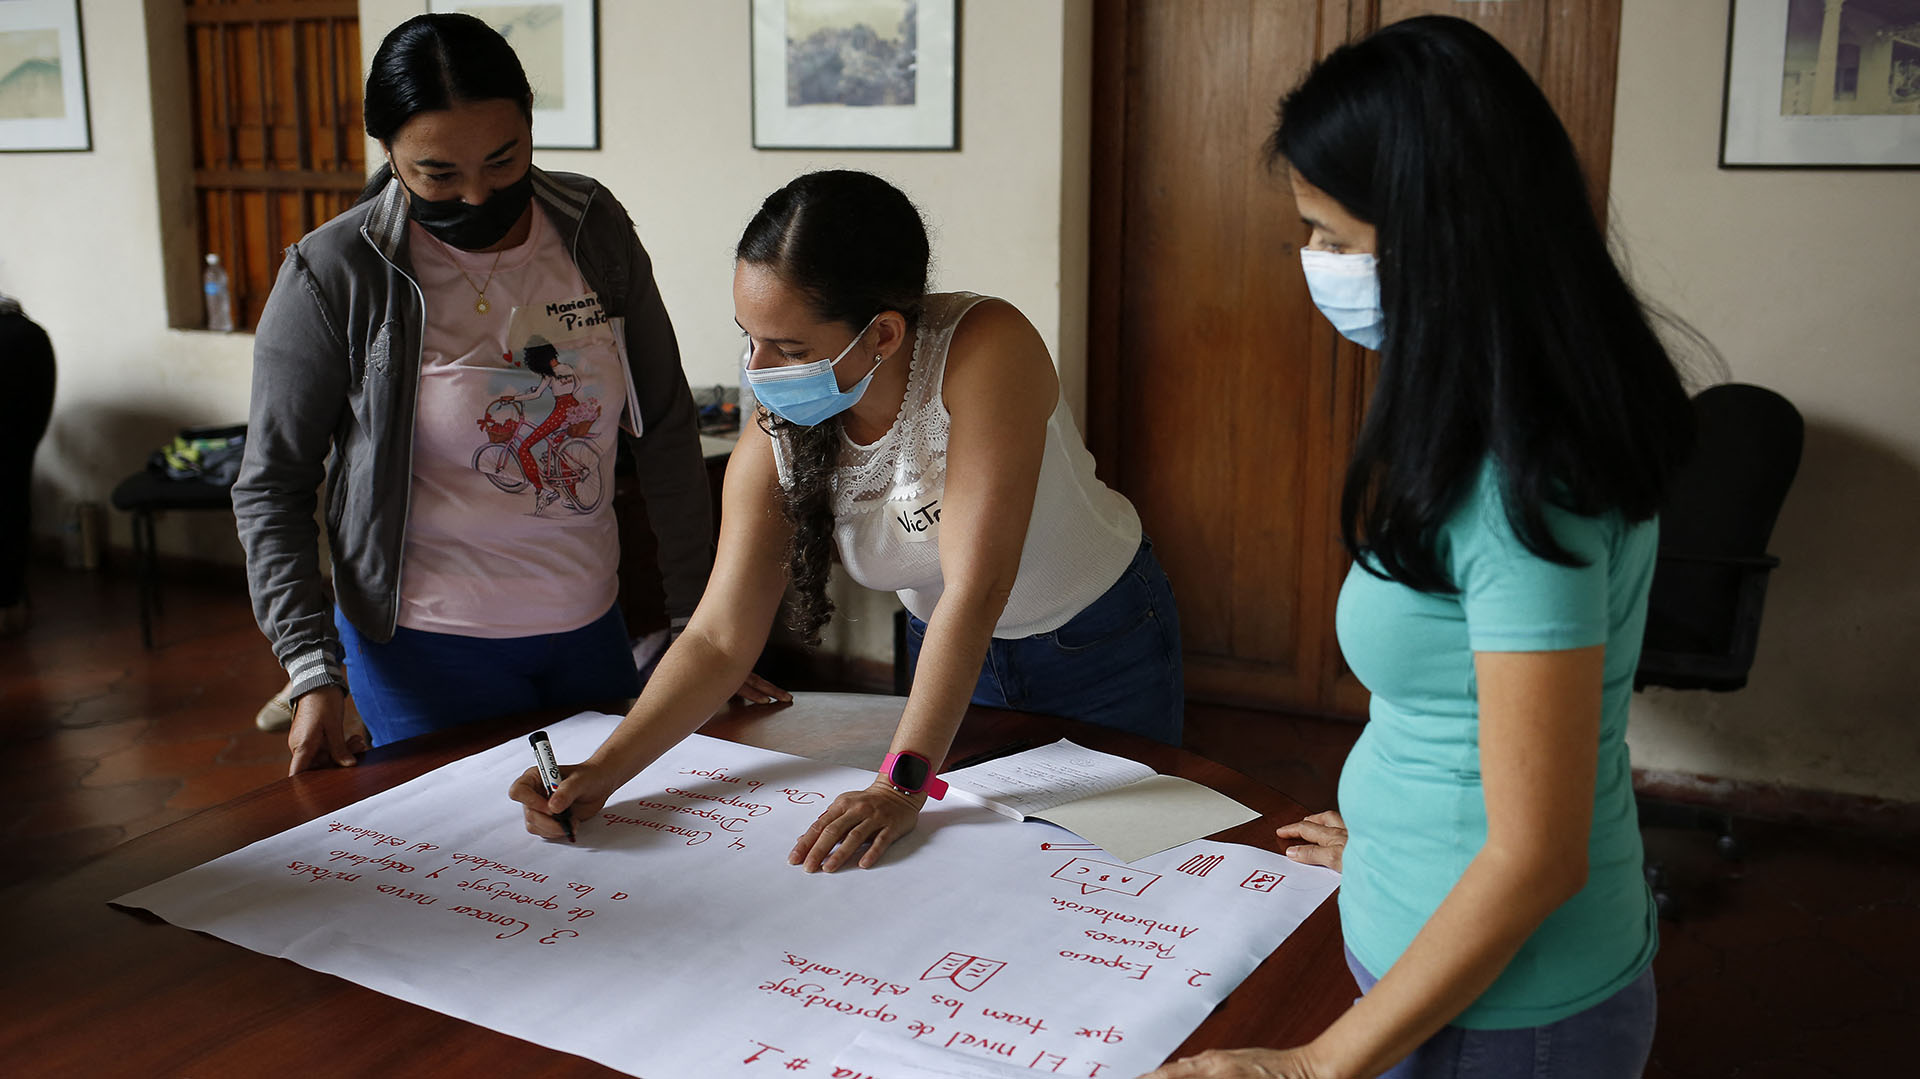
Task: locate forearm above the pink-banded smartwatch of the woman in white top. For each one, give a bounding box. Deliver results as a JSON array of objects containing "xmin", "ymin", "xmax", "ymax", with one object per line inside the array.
[{"xmin": 893, "ymin": 589, "xmax": 1006, "ymax": 768}]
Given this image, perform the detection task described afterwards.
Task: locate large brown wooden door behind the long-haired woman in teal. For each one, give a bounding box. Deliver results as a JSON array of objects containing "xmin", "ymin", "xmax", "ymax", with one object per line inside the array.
[{"xmin": 1087, "ymin": 0, "xmax": 1619, "ymax": 716}]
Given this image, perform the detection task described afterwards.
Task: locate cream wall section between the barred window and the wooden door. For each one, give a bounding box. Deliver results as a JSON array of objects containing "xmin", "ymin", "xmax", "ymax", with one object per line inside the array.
[{"xmin": 361, "ymin": 0, "xmax": 1091, "ymax": 399}]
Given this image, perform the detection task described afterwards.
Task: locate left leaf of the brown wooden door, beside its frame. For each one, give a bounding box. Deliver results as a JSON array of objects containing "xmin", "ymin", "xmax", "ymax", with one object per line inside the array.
[{"xmin": 1117, "ymin": 0, "xmax": 1317, "ymax": 698}]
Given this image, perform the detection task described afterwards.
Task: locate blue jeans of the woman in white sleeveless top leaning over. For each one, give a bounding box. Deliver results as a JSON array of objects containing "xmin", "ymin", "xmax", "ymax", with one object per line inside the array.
[{"xmin": 906, "ymin": 536, "xmax": 1187, "ymax": 745}]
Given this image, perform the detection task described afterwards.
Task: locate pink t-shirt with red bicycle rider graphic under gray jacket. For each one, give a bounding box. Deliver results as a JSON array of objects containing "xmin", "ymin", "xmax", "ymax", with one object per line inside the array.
[{"xmin": 399, "ymin": 211, "xmax": 626, "ymax": 637}]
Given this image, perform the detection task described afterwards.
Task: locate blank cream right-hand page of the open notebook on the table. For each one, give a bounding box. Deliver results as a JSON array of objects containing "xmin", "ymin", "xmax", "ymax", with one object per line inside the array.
[{"xmin": 1033, "ymin": 776, "xmax": 1260, "ymax": 862}]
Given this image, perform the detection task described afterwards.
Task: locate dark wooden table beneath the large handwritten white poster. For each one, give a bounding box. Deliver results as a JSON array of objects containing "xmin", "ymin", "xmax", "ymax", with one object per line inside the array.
[{"xmin": 0, "ymin": 697, "xmax": 1356, "ymax": 1079}]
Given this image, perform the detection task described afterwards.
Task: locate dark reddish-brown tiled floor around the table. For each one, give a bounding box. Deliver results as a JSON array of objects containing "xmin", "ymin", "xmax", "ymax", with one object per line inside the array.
[{"xmin": 0, "ymin": 556, "xmax": 1920, "ymax": 1079}]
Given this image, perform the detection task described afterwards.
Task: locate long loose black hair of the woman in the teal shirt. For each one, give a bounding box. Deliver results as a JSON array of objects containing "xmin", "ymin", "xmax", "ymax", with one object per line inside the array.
[{"xmin": 1267, "ymin": 15, "xmax": 1693, "ymax": 591}]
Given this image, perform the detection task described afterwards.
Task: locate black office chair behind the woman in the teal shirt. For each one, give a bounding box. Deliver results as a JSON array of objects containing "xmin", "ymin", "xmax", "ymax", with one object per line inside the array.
[{"xmin": 1634, "ymin": 382, "xmax": 1805, "ymax": 916}]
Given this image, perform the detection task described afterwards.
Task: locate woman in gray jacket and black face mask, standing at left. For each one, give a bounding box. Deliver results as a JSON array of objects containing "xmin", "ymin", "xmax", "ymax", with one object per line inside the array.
[{"xmin": 234, "ymin": 13, "xmax": 770, "ymax": 772}]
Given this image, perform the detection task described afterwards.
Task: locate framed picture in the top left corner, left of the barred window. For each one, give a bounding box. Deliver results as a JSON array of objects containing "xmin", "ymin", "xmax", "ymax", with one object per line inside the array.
[{"xmin": 0, "ymin": 0, "xmax": 94, "ymax": 150}]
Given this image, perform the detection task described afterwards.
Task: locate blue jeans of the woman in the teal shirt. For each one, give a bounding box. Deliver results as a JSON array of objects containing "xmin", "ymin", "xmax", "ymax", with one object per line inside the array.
[{"xmin": 1346, "ymin": 948, "xmax": 1655, "ymax": 1079}]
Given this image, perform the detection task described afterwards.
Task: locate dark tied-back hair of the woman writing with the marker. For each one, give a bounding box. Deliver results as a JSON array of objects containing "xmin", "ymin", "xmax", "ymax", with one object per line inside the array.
[{"xmin": 733, "ymin": 169, "xmax": 929, "ymax": 645}]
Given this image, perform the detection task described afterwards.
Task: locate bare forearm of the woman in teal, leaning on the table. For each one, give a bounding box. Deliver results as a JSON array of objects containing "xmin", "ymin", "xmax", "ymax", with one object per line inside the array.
[{"xmin": 1306, "ymin": 847, "xmax": 1578, "ymax": 1079}]
